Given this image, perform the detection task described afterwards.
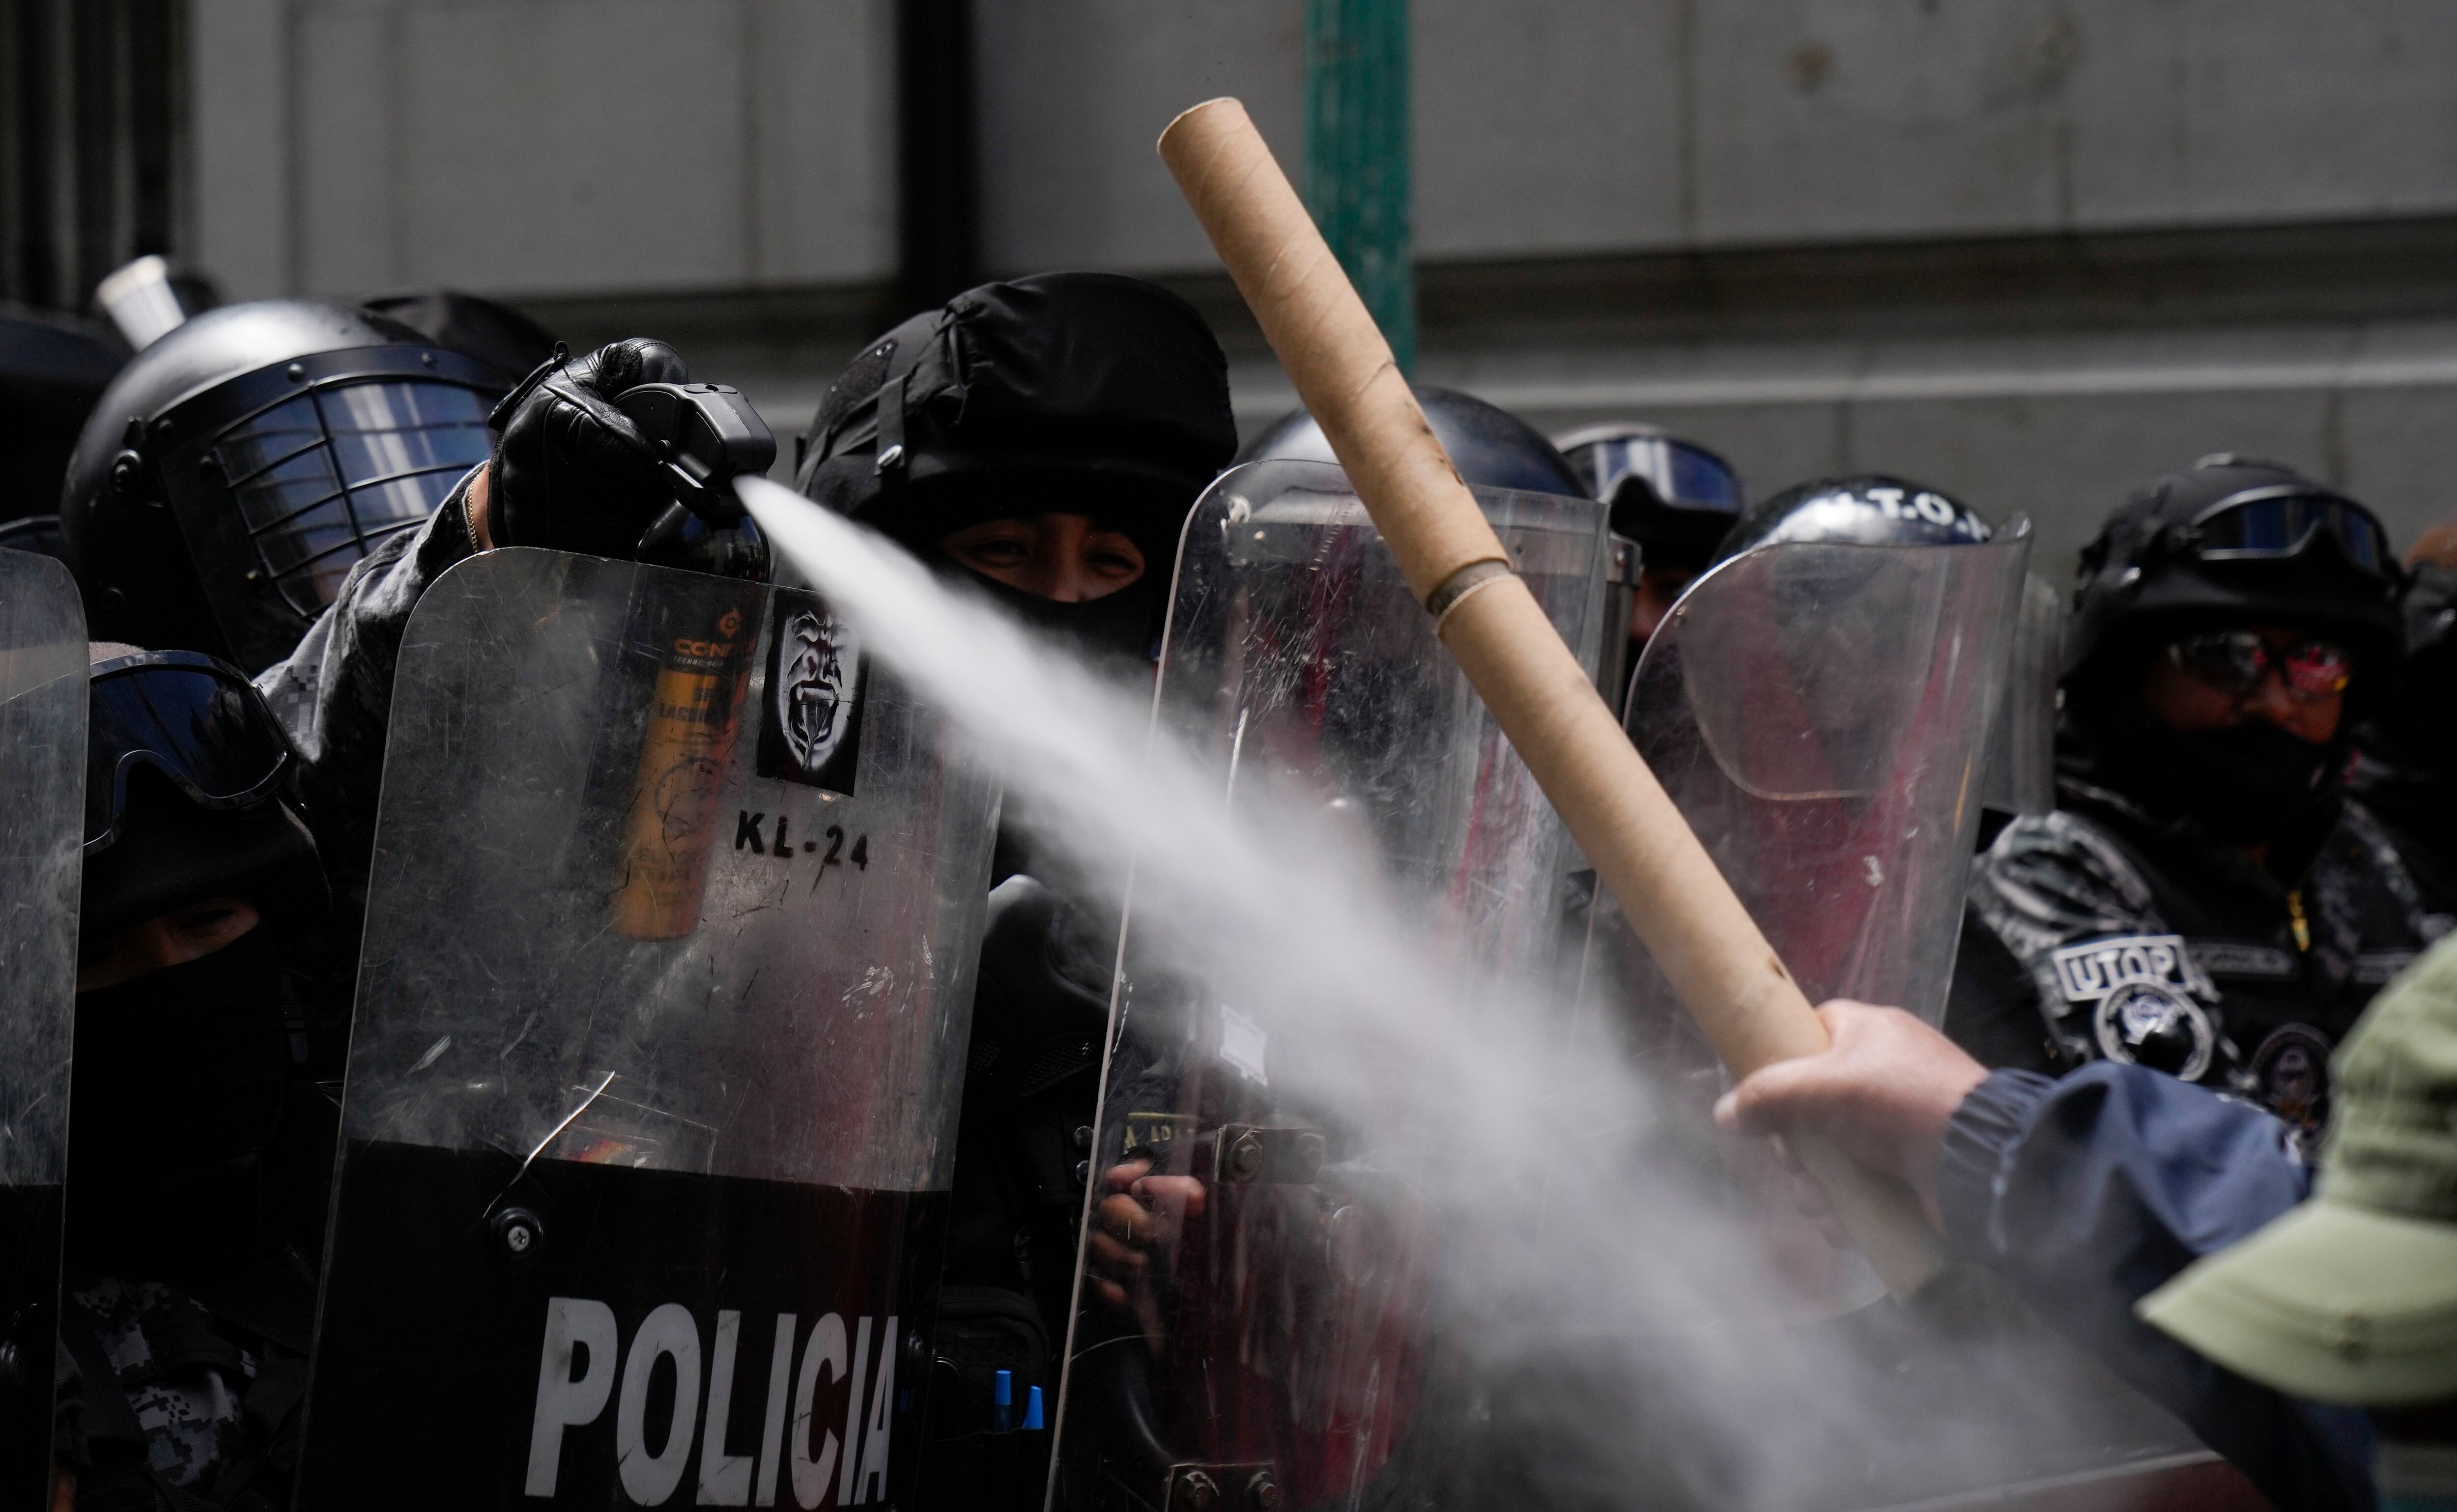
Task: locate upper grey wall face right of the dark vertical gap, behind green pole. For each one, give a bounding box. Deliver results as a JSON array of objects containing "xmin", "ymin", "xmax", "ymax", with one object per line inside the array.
[{"xmin": 983, "ymin": 0, "xmax": 2457, "ymax": 268}]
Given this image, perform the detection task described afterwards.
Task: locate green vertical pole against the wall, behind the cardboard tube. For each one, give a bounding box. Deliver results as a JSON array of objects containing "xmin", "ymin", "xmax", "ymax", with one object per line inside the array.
[{"xmin": 1305, "ymin": 0, "xmax": 1415, "ymax": 373}]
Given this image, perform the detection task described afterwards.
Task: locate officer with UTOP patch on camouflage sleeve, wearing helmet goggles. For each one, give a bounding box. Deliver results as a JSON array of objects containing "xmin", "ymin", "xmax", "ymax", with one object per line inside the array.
[{"xmin": 1946, "ymin": 455, "xmax": 2430, "ymax": 1131}]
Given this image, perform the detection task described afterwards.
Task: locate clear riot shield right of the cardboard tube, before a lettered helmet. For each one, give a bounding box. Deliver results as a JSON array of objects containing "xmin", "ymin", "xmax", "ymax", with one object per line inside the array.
[{"xmin": 1585, "ymin": 533, "xmax": 2029, "ymax": 1328}]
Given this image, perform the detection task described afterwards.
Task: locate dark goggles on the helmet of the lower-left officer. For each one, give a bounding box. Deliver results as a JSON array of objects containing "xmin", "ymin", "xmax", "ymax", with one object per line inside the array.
[{"xmin": 86, "ymin": 652, "xmax": 290, "ymax": 856}]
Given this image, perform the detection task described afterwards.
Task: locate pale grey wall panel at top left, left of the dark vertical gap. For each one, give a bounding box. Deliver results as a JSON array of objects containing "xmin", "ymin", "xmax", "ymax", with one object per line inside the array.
[{"xmin": 194, "ymin": 0, "xmax": 894, "ymax": 295}]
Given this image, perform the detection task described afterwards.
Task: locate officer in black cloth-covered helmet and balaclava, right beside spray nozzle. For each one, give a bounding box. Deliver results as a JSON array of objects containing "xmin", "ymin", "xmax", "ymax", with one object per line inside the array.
[{"xmin": 796, "ymin": 273, "xmax": 1236, "ymax": 1507}]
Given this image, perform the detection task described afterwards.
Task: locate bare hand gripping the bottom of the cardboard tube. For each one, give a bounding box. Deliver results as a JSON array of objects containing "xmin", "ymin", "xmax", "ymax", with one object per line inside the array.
[{"xmin": 1715, "ymin": 998, "xmax": 1988, "ymax": 1227}]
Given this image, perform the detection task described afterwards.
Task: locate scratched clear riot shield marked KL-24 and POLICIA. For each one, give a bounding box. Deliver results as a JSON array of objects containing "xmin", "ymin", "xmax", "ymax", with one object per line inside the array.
[{"xmin": 297, "ymin": 551, "xmax": 995, "ymax": 1512}]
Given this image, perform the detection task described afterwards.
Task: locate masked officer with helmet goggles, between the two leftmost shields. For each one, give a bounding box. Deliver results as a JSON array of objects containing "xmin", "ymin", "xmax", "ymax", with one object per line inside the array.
[{"xmin": 59, "ymin": 642, "xmax": 334, "ymax": 1510}]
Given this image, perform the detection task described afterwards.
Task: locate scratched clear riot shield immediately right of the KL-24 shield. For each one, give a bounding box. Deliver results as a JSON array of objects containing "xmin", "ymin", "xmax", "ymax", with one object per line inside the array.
[{"xmin": 1052, "ymin": 462, "xmax": 1607, "ymax": 1512}]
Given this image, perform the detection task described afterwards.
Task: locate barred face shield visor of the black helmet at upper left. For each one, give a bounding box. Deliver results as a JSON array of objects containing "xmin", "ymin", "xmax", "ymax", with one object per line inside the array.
[{"xmin": 214, "ymin": 379, "xmax": 489, "ymax": 617}]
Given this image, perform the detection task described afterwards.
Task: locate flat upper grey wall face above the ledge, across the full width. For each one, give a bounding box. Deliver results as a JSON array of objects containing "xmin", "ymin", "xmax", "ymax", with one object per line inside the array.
[{"xmin": 194, "ymin": 0, "xmax": 2457, "ymax": 295}]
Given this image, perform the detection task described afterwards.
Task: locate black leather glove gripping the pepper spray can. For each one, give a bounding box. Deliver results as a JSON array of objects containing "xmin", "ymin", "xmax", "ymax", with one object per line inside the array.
[{"xmin": 486, "ymin": 337, "xmax": 690, "ymax": 558}]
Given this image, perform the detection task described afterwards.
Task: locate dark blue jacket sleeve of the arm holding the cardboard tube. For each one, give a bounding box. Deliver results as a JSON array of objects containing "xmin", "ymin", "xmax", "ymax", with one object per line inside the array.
[{"xmin": 1936, "ymin": 1062, "xmax": 2371, "ymax": 1512}]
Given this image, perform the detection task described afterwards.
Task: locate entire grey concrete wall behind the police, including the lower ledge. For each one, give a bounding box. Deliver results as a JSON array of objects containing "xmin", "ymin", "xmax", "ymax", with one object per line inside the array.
[{"xmin": 194, "ymin": 0, "xmax": 2457, "ymax": 571}]
